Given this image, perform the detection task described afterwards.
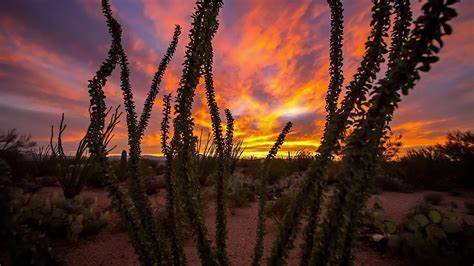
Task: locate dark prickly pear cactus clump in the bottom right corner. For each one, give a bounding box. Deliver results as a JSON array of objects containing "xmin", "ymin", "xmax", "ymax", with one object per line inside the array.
[{"xmin": 388, "ymin": 205, "xmax": 474, "ymax": 265}]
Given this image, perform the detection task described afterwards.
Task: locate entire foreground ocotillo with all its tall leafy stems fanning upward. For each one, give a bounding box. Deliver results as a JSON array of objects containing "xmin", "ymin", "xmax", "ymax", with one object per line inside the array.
[{"xmin": 78, "ymin": 0, "xmax": 456, "ymax": 265}]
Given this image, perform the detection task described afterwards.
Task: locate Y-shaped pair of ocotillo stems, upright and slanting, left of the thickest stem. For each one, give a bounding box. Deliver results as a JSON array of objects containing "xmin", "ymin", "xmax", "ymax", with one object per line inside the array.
[{"xmin": 271, "ymin": 0, "xmax": 390, "ymax": 265}]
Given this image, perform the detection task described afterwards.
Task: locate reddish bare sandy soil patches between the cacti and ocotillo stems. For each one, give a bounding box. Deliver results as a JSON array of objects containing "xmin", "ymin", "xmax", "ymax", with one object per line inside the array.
[{"xmin": 40, "ymin": 188, "xmax": 474, "ymax": 266}]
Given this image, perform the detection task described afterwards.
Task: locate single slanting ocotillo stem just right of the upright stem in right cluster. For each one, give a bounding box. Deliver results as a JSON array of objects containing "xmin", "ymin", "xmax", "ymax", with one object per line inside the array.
[{"xmin": 268, "ymin": 0, "xmax": 390, "ymax": 265}]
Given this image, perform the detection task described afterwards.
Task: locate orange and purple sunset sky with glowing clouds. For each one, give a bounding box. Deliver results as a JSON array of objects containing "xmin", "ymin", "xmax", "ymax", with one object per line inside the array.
[{"xmin": 0, "ymin": 0, "xmax": 474, "ymax": 155}]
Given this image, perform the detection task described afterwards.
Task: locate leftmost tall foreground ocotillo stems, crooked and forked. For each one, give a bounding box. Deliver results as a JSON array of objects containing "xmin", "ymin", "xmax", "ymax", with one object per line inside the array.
[{"xmin": 88, "ymin": 0, "xmax": 180, "ymax": 265}]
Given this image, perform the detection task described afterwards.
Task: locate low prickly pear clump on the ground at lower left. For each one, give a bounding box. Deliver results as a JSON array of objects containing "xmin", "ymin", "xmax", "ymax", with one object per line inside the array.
[{"xmin": 10, "ymin": 190, "xmax": 108, "ymax": 241}]
